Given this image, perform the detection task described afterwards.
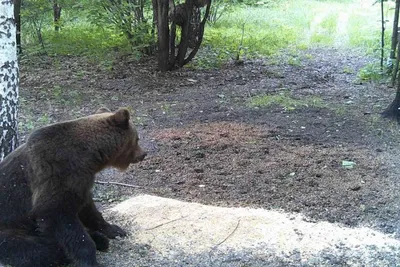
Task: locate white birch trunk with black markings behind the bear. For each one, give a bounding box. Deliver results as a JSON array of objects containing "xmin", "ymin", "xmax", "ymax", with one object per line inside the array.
[{"xmin": 0, "ymin": 0, "xmax": 19, "ymax": 161}]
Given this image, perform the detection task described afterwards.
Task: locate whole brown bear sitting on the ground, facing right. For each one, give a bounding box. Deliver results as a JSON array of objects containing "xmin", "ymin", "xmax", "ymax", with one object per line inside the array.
[{"xmin": 0, "ymin": 108, "xmax": 146, "ymax": 267}]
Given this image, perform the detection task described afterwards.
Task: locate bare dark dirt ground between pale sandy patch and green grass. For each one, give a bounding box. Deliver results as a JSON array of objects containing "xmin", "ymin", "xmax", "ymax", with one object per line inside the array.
[{"xmin": 20, "ymin": 49, "xmax": 400, "ymax": 266}]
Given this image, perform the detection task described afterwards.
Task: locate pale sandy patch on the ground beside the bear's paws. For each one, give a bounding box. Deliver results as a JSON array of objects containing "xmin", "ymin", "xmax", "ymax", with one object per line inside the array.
[{"xmin": 99, "ymin": 195, "xmax": 400, "ymax": 266}]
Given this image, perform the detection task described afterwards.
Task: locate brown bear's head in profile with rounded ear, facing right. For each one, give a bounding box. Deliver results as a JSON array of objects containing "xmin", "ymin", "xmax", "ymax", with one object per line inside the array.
[{"xmin": 97, "ymin": 108, "xmax": 147, "ymax": 170}]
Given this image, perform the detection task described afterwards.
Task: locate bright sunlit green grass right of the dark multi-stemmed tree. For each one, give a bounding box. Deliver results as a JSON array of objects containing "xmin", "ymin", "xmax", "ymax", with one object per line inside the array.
[{"xmin": 192, "ymin": 0, "xmax": 392, "ymax": 67}]
